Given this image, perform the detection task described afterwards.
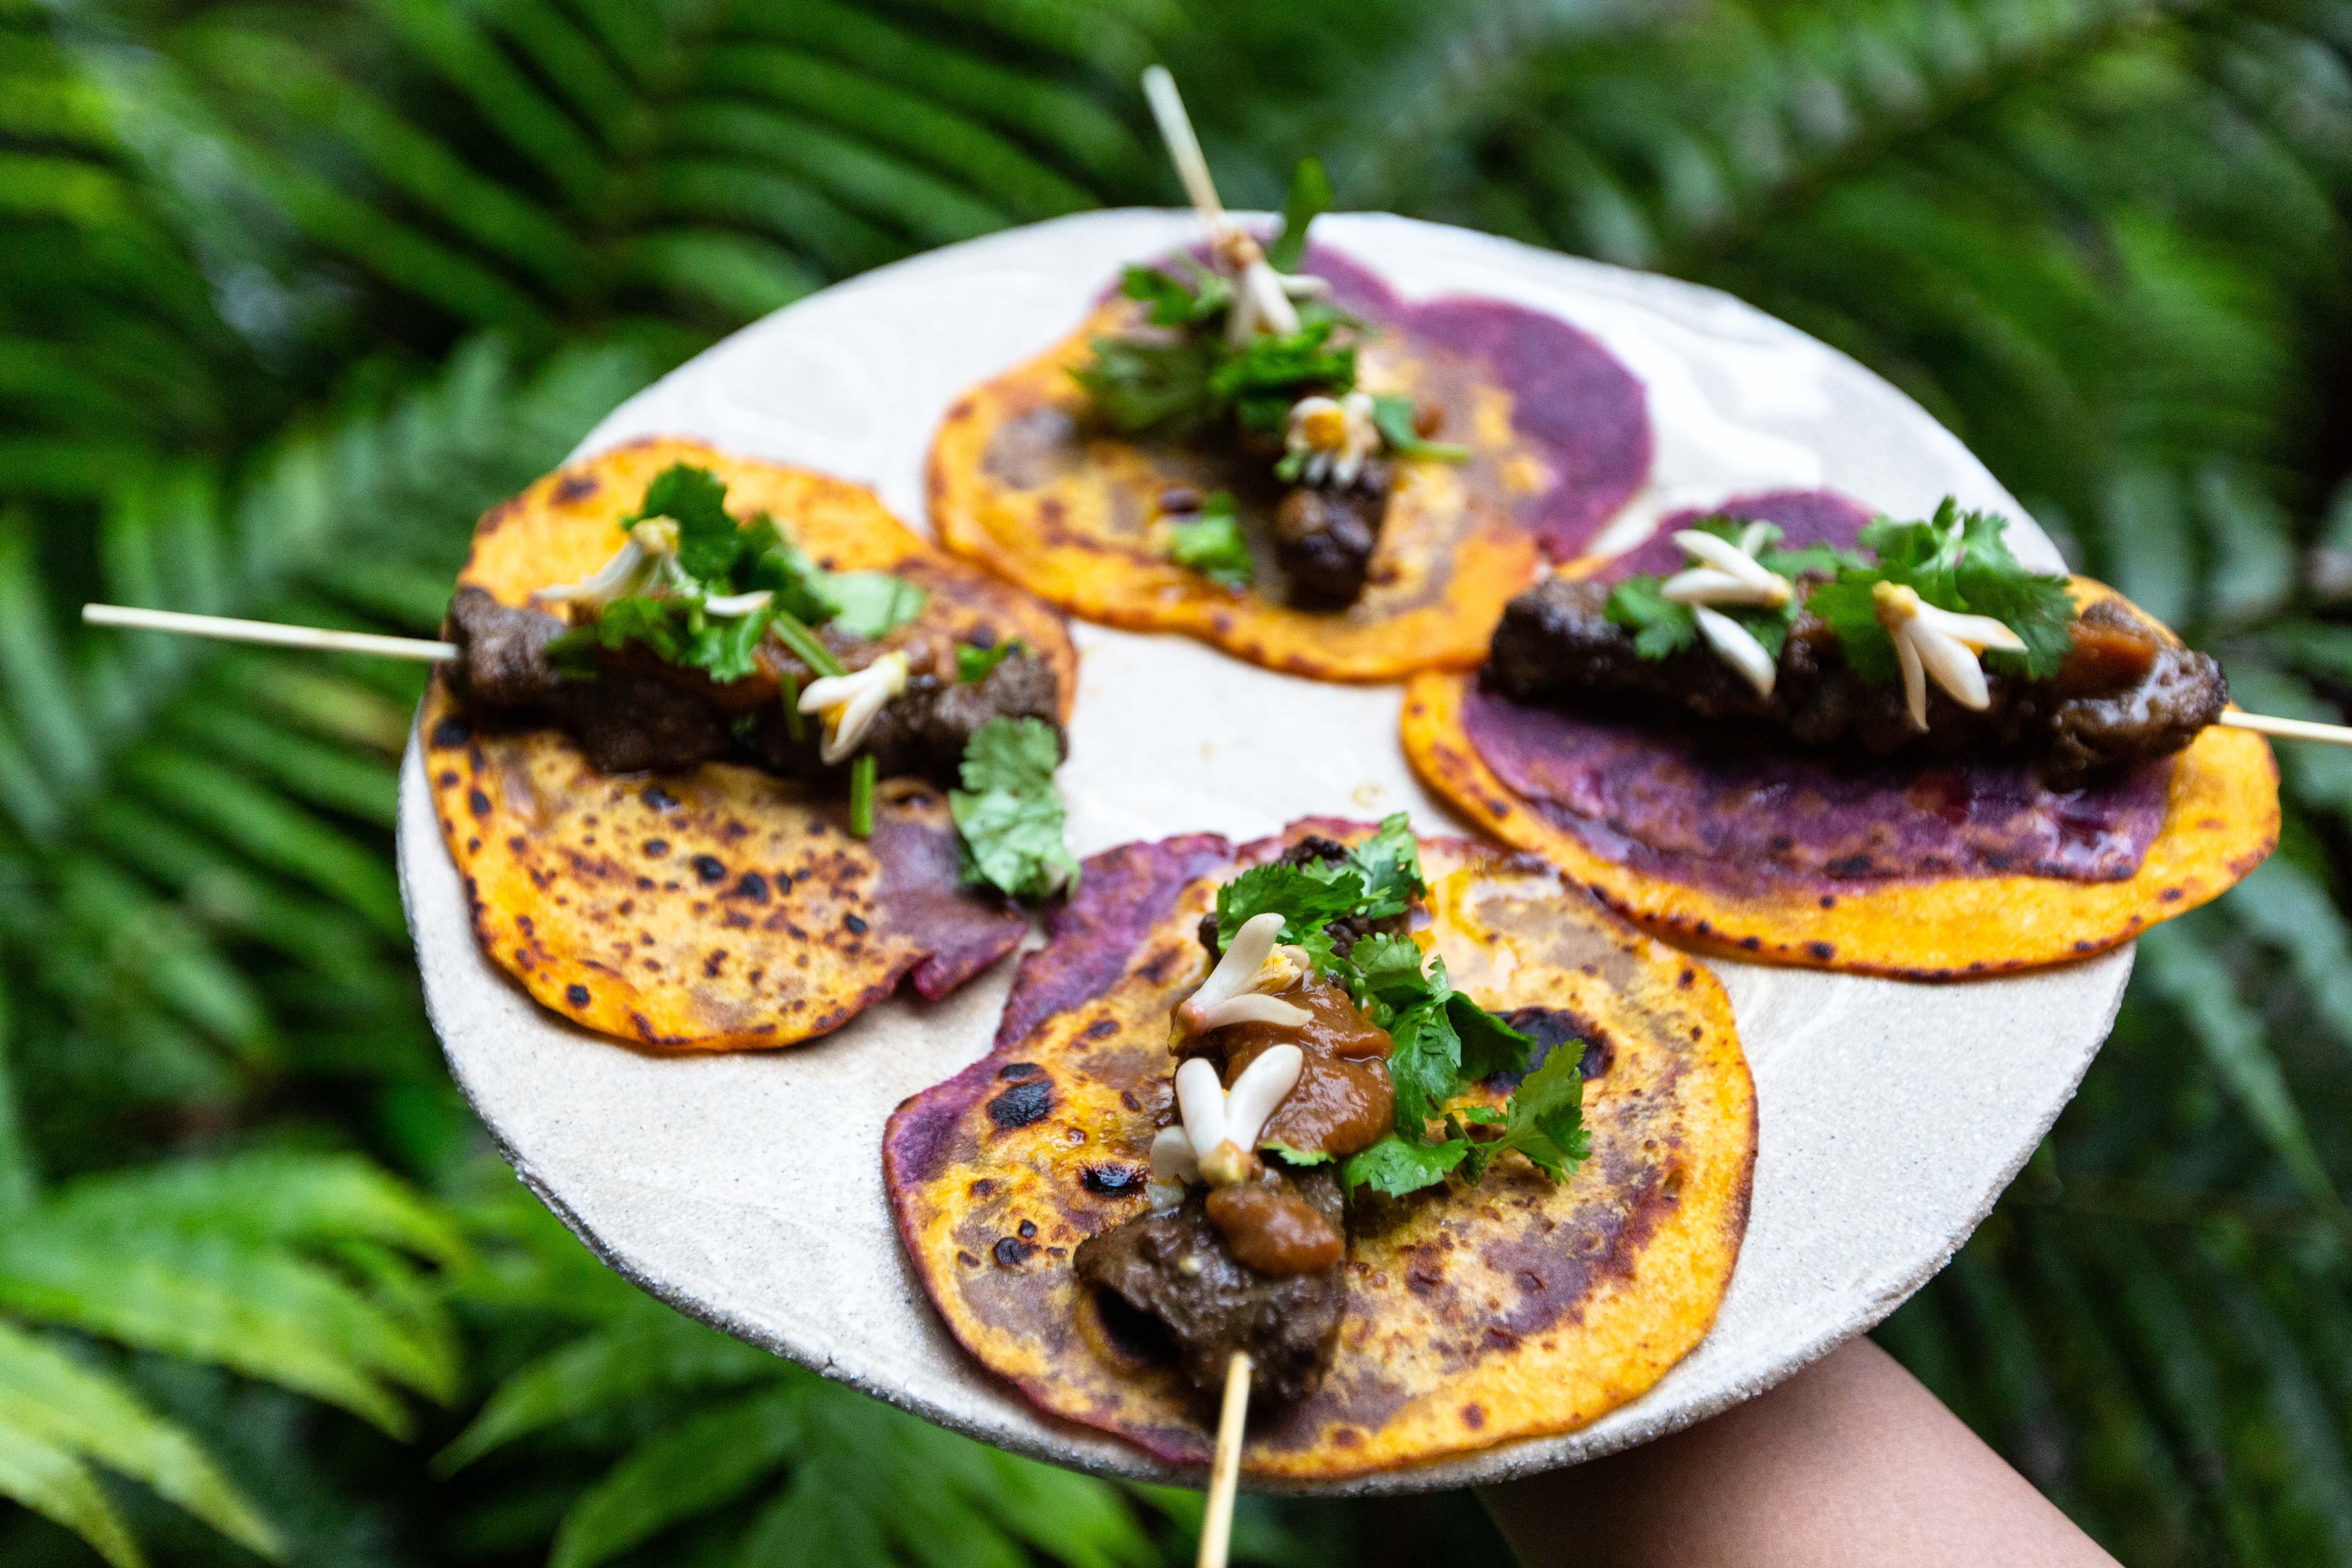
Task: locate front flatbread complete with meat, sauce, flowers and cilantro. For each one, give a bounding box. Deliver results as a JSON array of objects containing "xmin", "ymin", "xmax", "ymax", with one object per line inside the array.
[{"xmin": 884, "ymin": 818, "xmax": 1754, "ymax": 1479}]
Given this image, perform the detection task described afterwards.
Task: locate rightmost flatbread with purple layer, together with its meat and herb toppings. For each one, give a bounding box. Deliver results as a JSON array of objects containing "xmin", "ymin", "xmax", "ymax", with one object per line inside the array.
[{"xmin": 1402, "ymin": 491, "xmax": 2279, "ymax": 978}]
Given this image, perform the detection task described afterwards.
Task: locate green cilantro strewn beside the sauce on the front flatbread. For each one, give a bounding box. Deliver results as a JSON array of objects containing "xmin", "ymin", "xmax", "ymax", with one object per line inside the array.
[{"xmin": 1216, "ymin": 811, "xmax": 1585, "ymax": 1197}]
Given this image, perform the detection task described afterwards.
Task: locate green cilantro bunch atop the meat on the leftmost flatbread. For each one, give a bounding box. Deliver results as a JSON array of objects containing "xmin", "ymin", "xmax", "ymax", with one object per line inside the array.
[{"xmin": 548, "ymin": 463, "xmax": 924, "ymax": 682}]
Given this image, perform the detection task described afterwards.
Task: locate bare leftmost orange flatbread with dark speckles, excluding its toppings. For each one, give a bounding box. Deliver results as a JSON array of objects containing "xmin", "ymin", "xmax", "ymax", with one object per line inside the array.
[{"xmin": 419, "ymin": 440, "xmax": 1077, "ymax": 1051}]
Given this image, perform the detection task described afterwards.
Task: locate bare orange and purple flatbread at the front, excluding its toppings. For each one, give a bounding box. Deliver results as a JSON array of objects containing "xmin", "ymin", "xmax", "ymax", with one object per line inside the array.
[{"xmin": 882, "ymin": 820, "xmax": 1757, "ymax": 1479}]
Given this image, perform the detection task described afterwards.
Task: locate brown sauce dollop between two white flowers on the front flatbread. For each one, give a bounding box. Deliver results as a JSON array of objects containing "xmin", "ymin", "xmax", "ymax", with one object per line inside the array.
[{"xmin": 1185, "ymin": 980, "xmax": 1397, "ymax": 1159}]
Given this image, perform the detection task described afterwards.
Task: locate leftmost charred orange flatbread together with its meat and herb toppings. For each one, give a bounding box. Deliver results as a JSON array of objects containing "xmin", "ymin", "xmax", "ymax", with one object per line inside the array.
[{"xmin": 421, "ymin": 440, "xmax": 1075, "ymax": 1051}]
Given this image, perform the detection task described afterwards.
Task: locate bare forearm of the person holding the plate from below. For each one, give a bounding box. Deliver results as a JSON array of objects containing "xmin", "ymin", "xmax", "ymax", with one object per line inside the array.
[{"xmin": 1479, "ymin": 1340, "xmax": 2115, "ymax": 1568}]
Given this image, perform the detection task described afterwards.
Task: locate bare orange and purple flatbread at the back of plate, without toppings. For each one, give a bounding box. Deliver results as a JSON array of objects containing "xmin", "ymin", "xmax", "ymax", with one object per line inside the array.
[{"xmin": 929, "ymin": 247, "xmax": 1653, "ymax": 682}]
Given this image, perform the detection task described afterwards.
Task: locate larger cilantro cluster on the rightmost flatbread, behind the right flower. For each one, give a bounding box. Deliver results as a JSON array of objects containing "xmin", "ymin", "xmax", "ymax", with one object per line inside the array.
[{"xmin": 1806, "ymin": 496, "xmax": 2074, "ymax": 684}]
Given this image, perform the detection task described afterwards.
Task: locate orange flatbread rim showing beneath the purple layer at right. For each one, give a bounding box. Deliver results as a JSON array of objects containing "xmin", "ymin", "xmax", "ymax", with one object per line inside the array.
[{"xmin": 1402, "ymin": 578, "xmax": 2279, "ymax": 980}]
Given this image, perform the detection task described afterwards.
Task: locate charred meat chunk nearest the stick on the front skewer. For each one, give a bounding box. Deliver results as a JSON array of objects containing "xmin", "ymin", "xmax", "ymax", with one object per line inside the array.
[{"xmin": 1070, "ymin": 1171, "xmax": 1348, "ymax": 1403}]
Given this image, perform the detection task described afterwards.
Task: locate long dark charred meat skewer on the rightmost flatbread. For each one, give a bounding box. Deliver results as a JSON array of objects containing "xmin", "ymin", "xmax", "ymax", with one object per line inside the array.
[{"xmin": 1484, "ymin": 578, "xmax": 2230, "ymax": 790}]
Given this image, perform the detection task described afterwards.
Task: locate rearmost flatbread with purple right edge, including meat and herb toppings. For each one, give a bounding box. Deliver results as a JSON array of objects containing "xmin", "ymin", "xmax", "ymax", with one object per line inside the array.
[{"xmin": 929, "ymin": 247, "xmax": 1653, "ymax": 679}]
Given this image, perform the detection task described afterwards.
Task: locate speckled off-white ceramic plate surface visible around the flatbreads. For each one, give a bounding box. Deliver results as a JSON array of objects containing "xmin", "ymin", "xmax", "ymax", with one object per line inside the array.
[{"xmin": 400, "ymin": 212, "xmax": 2131, "ymax": 1493}]
